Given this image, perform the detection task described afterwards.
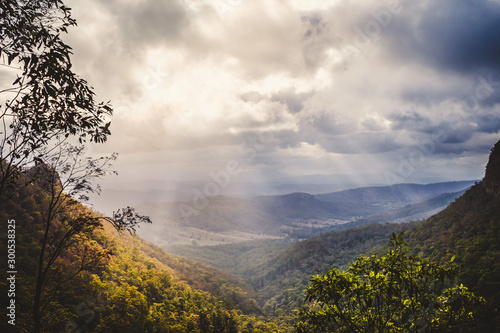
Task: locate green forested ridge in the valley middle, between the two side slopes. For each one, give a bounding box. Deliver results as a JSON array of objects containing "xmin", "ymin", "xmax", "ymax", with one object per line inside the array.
[{"xmin": 167, "ymin": 223, "xmax": 414, "ymax": 317}]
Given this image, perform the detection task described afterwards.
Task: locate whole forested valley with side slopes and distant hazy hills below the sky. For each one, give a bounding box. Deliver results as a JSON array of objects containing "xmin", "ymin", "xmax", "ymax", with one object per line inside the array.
[{"xmin": 0, "ymin": 142, "xmax": 500, "ymax": 332}]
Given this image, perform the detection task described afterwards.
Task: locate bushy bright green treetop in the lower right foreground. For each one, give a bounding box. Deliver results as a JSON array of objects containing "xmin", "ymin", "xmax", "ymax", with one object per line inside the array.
[{"xmin": 295, "ymin": 233, "xmax": 486, "ymax": 332}]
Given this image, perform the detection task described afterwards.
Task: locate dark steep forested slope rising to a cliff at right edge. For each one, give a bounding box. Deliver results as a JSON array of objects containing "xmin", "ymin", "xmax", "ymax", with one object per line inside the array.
[{"xmin": 407, "ymin": 141, "xmax": 500, "ymax": 324}]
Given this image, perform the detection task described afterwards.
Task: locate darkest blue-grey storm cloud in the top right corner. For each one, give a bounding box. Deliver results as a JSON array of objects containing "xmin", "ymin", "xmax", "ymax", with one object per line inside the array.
[{"xmin": 386, "ymin": 0, "xmax": 500, "ymax": 73}]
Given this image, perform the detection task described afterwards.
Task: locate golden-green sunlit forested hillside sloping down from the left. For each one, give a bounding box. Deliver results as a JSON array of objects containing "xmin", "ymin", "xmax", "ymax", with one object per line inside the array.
[{"xmin": 0, "ymin": 167, "xmax": 283, "ymax": 333}]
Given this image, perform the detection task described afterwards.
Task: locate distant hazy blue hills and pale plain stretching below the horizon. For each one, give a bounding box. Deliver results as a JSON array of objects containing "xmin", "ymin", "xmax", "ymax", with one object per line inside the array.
[{"xmin": 137, "ymin": 181, "xmax": 473, "ymax": 246}]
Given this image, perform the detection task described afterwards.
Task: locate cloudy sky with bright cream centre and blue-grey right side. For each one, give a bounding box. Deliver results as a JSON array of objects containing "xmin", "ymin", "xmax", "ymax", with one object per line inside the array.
[{"xmin": 65, "ymin": 0, "xmax": 500, "ymax": 185}]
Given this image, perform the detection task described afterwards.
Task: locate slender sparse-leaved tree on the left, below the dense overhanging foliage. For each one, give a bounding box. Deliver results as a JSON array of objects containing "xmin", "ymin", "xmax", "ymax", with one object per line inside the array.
[{"xmin": 28, "ymin": 143, "xmax": 151, "ymax": 332}]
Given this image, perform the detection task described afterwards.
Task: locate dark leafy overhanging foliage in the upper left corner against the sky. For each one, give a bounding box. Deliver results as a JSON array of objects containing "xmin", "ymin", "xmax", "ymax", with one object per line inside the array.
[{"xmin": 0, "ymin": 0, "xmax": 112, "ymax": 200}]
